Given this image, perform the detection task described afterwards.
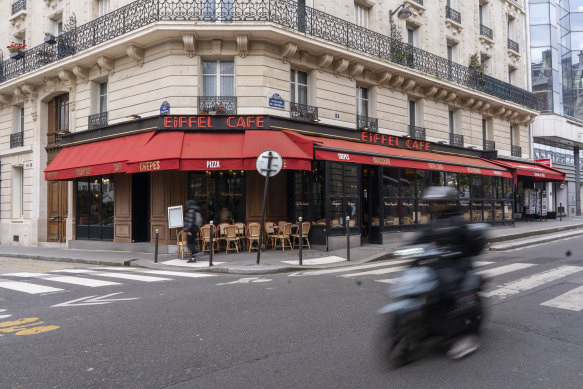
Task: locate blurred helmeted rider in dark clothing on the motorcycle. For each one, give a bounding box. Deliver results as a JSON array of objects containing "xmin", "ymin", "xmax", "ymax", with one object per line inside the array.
[{"xmin": 414, "ymin": 186, "xmax": 484, "ymax": 359}]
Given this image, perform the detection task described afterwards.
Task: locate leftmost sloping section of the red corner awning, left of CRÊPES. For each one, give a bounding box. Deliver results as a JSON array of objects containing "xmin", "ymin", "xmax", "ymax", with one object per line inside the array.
[{"xmin": 45, "ymin": 132, "xmax": 153, "ymax": 180}]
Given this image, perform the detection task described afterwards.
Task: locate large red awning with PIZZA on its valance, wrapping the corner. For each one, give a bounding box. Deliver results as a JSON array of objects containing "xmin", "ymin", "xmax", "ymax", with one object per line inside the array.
[{"xmin": 45, "ymin": 130, "xmax": 313, "ymax": 180}]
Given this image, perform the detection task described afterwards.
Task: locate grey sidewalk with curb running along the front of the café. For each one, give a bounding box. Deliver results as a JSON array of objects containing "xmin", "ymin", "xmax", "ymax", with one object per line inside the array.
[{"xmin": 0, "ymin": 217, "xmax": 583, "ymax": 274}]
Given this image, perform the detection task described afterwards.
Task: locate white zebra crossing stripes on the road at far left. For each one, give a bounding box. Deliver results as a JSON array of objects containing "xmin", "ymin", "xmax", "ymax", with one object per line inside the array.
[{"xmin": 0, "ymin": 267, "xmax": 216, "ymax": 295}]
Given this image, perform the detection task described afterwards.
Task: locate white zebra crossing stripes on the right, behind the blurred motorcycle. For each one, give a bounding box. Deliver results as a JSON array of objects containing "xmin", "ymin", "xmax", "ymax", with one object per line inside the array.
[{"xmin": 294, "ymin": 259, "xmax": 583, "ymax": 311}]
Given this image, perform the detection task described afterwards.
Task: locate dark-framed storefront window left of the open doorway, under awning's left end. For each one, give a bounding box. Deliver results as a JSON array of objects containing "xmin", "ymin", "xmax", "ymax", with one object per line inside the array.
[{"xmin": 75, "ymin": 176, "xmax": 114, "ymax": 240}]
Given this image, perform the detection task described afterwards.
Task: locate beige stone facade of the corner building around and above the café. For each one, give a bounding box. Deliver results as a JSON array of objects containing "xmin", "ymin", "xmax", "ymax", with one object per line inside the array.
[{"xmin": 0, "ymin": 0, "xmax": 537, "ymax": 245}]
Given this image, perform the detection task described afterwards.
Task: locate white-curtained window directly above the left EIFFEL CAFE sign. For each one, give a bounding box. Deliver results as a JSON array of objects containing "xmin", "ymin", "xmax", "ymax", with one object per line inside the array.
[{"xmin": 202, "ymin": 61, "xmax": 235, "ymax": 96}]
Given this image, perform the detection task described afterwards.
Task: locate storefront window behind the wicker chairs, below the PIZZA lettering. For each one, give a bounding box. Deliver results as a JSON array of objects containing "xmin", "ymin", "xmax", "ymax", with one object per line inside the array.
[{"xmin": 188, "ymin": 170, "xmax": 246, "ymax": 224}]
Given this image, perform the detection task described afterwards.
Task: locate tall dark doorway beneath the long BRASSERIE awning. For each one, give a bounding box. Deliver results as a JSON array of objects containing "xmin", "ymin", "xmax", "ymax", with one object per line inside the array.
[{"xmin": 361, "ymin": 165, "xmax": 383, "ymax": 244}]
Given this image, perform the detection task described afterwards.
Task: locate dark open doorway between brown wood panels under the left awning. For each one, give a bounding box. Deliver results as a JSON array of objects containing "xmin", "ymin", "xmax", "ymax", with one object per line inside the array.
[{"xmin": 132, "ymin": 173, "xmax": 150, "ymax": 243}]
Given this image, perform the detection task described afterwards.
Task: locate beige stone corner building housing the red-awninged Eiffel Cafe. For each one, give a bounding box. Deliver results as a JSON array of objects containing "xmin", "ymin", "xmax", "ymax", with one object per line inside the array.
[{"xmin": 0, "ymin": 0, "xmax": 564, "ymax": 251}]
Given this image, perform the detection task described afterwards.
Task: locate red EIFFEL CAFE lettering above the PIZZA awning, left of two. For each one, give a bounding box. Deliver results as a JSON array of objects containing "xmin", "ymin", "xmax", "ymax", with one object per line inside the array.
[{"xmin": 160, "ymin": 115, "xmax": 265, "ymax": 130}]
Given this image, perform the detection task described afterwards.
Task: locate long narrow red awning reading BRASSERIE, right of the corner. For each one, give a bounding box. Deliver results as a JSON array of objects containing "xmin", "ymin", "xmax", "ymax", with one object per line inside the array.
[{"xmin": 290, "ymin": 135, "xmax": 512, "ymax": 178}]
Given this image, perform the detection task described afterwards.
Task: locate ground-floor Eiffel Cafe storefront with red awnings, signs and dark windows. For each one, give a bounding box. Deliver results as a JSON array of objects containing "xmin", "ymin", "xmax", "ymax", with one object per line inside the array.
[{"xmin": 45, "ymin": 115, "xmax": 564, "ymax": 252}]
